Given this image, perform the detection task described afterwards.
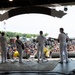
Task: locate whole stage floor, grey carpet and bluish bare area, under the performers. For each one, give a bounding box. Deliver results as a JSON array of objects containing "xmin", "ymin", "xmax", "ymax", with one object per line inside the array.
[{"xmin": 0, "ymin": 58, "xmax": 75, "ymax": 75}]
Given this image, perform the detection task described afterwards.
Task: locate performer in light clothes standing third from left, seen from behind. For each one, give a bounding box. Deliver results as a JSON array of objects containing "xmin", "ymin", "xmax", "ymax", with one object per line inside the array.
[{"xmin": 36, "ymin": 31, "xmax": 46, "ymax": 63}]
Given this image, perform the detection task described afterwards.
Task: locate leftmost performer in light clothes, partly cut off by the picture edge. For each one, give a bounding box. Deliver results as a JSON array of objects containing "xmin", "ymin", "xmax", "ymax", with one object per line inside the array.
[{"xmin": 0, "ymin": 32, "xmax": 7, "ymax": 63}]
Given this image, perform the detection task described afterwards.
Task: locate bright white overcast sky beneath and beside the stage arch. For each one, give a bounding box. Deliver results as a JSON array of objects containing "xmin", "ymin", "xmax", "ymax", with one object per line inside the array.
[{"xmin": 0, "ymin": 6, "xmax": 75, "ymax": 38}]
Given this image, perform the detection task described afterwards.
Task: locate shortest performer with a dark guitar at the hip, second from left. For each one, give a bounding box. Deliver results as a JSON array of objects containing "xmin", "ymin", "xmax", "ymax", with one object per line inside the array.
[{"xmin": 16, "ymin": 35, "xmax": 23, "ymax": 63}]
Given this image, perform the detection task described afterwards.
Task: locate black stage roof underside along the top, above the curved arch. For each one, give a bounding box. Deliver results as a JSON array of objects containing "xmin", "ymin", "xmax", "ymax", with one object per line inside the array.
[{"xmin": 0, "ymin": 0, "xmax": 75, "ymax": 8}]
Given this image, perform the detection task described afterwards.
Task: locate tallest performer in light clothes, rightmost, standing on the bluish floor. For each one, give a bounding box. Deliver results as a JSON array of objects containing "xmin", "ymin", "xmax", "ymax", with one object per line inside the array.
[{"xmin": 58, "ymin": 28, "xmax": 69, "ymax": 63}]
